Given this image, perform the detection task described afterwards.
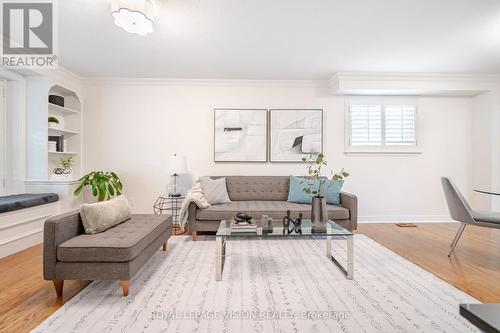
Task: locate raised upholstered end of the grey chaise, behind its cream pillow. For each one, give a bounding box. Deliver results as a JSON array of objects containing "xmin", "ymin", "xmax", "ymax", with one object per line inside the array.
[{"xmin": 43, "ymin": 211, "xmax": 84, "ymax": 280}]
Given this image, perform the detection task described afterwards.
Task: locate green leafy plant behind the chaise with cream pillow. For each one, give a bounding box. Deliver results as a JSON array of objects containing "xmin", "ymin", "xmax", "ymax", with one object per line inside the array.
[{"xmin": 73, "ymin": 171, "xmax": 123, "ymax": 201}]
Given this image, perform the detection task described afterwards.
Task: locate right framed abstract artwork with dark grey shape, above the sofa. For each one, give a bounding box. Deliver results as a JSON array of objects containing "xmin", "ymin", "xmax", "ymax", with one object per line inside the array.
[{"xmin": 269, "ymin": 109, "xmax": 323, "ymax": 162}]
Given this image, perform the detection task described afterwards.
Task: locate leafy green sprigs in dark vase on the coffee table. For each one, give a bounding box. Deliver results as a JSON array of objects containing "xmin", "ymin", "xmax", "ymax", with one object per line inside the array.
[{"xmin": 301, "ymin": 153, "xmax": 349, "ymax": 198}]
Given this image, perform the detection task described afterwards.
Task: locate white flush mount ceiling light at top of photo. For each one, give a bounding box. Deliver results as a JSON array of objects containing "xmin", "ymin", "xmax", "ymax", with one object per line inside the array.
[{"xmin": 111, "ymin": 0, "xmax": 155, "ymax": 36}]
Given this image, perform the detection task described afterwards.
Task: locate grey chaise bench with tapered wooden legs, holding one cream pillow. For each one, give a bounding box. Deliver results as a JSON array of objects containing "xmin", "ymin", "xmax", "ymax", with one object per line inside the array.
[{"xmin": 43, "ymin": 211, "xmax": 172, "ymax": 297}]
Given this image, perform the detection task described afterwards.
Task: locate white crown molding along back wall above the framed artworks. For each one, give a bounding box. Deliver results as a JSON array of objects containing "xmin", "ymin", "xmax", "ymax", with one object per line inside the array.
[{"xmin": 82, "ymin": 77, "xmax": 329, "ymax": 88}]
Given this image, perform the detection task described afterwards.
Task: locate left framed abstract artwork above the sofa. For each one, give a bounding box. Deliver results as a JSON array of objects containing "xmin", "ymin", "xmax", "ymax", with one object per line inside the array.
[{"xmin": 214, "ymin": 109, "xmax": 267, "ymax": 162}]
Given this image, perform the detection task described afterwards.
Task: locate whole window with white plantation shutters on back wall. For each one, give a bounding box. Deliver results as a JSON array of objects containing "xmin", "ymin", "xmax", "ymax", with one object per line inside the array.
[{"xmin": 345, "ymin": 98, "xmax": 418, "ymax": 153}]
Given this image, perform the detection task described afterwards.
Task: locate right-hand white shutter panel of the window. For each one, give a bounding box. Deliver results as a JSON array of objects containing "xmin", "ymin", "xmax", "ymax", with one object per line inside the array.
[{"xmin": 384, "ymin": 105, "xmax": 417, "ymax": 145}]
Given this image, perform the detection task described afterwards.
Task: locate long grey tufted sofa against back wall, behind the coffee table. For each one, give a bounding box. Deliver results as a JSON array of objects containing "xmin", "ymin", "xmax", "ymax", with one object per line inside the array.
[{"xmin": 188, "ymin": 176, "xmax": 358, "ymax": 240}]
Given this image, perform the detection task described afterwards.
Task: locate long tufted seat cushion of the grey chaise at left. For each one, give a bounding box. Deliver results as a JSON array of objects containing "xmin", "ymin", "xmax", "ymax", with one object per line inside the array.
[{"xmin": 57, "ymin": 214, "xmax": 172, "ymax": 262}]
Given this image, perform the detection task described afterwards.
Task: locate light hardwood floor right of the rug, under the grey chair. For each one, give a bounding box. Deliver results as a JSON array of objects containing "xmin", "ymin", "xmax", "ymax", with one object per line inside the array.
[{"xmin": 356, "ymin": 223, "xmax": 500, "ymax": 303}]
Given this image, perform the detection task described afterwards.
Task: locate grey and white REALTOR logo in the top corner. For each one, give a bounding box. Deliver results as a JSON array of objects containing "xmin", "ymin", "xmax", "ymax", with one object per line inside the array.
[{"xmin": 1, "ymin": 1, "xmax": 57, "ymax": 68}]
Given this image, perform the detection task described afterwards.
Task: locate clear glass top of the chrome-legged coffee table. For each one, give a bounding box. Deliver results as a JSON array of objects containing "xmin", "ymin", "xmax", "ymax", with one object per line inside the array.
[{"xmin": 217, "ymin": 219, "xmax": 352, "ymax": 237}]
